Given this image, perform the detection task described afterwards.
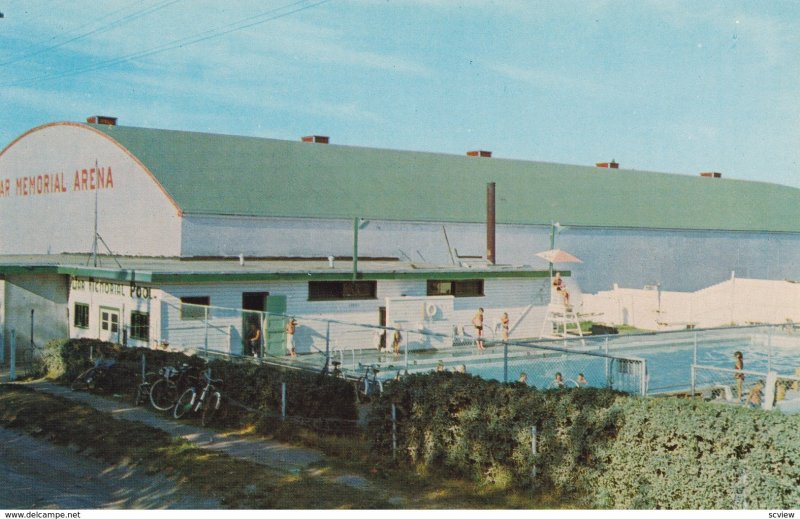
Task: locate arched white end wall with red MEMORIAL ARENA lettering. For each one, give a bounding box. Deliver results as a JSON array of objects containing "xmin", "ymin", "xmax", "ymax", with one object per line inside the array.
[{"xmin": 0, "ymin": 123, "xmax": 180, "ymax": 256}]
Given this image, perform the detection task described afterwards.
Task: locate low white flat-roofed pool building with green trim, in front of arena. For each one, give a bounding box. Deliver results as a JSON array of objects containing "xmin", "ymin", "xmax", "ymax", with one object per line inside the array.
[{"xmin": 0, "ymin": 255, "xmax": 550, "ymax": 355}]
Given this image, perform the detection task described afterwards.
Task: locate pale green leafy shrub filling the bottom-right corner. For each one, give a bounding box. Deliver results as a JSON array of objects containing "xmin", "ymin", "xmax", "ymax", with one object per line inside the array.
[{"xmin": 596, "ymin": 398, "xmax": 800, "ymax": 509}]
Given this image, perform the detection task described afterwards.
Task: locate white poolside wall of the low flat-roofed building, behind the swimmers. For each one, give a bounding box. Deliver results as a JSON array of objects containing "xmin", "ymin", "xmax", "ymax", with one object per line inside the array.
[{"xmin": 153, "ymin": 279, "xmax": 556, "ymax": 354}]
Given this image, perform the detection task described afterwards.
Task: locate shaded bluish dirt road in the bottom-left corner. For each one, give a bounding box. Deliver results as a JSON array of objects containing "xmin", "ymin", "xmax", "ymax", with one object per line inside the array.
[{"xmin": 0, "ymin": 428, "xmax": 220, "ymax": 509}]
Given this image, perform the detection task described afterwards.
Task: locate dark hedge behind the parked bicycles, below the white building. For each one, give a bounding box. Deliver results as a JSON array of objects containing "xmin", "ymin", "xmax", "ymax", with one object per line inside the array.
[{"xmin": 43, "ymin": 339, "xmax": 357, "ymax": 423}]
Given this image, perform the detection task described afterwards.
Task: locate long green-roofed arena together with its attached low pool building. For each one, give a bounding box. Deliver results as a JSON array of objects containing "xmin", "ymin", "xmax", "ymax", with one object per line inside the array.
[{"xmin": 0, "ymin": 117, "xmax": 800, "ymax": 360}]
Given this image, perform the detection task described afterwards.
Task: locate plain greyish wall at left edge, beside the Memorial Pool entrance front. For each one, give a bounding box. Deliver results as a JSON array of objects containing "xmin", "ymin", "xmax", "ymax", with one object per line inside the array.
[{"xmin": 0, "ymin": 274, "xmax": 69, "ymax": 363}]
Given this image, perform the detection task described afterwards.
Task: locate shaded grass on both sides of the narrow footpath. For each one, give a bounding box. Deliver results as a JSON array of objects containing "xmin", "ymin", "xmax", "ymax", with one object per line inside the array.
[{"xmin": 0, "ymin": 385, "xmax": 568, "ymax": 509}]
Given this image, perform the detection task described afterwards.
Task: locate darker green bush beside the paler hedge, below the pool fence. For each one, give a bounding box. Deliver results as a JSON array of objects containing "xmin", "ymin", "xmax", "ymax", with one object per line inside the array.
[{"xmin": 369, "ymin": 372, "xmax": 618, "ymax": 502}]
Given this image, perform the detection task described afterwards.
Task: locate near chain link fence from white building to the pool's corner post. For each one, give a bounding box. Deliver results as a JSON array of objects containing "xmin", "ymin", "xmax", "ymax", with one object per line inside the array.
[{"xmin": 155, "ymin": 302, "xmax": 647, "ymax": 394}]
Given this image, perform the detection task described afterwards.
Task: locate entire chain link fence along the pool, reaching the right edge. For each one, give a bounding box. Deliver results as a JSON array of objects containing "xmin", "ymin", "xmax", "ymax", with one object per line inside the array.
[{"xmin": 150, "ymin": 302, "xmax": 800, "ymax": 395}]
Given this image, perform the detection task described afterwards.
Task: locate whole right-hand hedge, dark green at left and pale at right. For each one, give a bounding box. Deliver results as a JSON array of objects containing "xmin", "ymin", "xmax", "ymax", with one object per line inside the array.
[{"xmin": 368, "ymin": 373, "xmax": 800, "ymax": 509}]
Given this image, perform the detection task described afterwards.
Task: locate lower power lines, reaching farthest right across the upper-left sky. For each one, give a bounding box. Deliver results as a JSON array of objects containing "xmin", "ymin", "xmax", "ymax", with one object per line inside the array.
[{"xmin": 0, "ymin": 0, "xmax": 331, "ymax": 87}]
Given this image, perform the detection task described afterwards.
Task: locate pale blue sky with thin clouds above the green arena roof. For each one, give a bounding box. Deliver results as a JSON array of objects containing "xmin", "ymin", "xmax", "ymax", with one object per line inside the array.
[{"xmin": 0, "ymin": 0, "xmax": 800, "ymax": 187}]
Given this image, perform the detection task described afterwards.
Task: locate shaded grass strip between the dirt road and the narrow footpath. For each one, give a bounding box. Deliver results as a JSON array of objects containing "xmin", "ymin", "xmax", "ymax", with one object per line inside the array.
[{"xmin": 0, "ymin": 385, "xmax": 391, "ymax": 509}]
